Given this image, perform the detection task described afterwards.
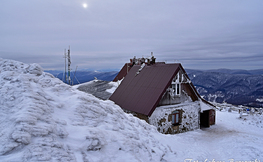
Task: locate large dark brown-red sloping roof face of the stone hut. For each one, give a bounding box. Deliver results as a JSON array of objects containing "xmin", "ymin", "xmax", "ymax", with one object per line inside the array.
[{"xmin": 110, "ymin": 64, "xmax": 183, "ymax": 116}]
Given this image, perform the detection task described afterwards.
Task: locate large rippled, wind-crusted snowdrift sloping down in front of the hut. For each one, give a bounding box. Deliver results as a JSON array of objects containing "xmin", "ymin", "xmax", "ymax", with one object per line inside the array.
[{"xmin": 0, "ymin": 59, "xmax": 173, "ymax": 162}]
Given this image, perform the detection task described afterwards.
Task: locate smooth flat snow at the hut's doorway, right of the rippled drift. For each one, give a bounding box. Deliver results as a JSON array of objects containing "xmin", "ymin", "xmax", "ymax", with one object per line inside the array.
[{"xmin": 165, "ymin": 111, "xmax": 263, "ymax": 162}]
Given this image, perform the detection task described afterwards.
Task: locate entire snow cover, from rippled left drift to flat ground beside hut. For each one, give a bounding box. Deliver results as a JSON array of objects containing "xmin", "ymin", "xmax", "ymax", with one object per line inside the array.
[{"xmin": 0, "ymin": 58, "xmax": 263, "ymax": 162}]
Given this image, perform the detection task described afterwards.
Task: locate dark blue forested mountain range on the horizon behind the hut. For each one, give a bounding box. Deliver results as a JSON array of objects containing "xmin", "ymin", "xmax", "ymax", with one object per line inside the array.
[{"xmin": 46, "ymin": 69, "xmax": 263, "ymax": 107}]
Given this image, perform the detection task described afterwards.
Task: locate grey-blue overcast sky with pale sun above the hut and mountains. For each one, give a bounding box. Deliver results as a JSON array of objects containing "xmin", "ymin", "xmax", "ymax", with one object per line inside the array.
[{"xmin": 0, "ymin": 0, "xmax": 263, "ymax": 70}]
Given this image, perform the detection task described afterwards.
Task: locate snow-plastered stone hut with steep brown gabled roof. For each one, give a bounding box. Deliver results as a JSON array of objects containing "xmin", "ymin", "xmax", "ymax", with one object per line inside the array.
[{"xmin": 109, "ymin": 57, "xmax": 215, "ymax": 134}]
